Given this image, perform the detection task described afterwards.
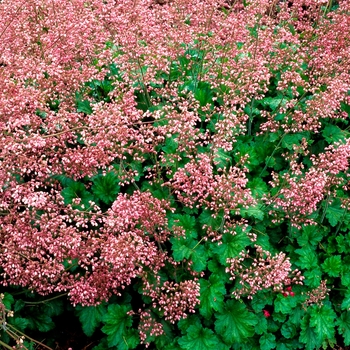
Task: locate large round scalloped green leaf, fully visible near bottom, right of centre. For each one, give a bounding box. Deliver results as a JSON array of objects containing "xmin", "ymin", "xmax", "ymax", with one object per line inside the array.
[{"xmin": 215, "ymin": 300, "xmax": 258, "ymax": 344}]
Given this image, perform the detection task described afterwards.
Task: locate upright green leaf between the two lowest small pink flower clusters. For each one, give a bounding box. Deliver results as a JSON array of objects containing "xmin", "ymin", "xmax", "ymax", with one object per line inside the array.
[{"xmin": 199, "ymin": 274, "xmax": 226, "ymax": 318}]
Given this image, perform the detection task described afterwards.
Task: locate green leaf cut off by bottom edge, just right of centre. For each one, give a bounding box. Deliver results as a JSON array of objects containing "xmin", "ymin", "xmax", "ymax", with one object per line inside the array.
[{"xmin": 178, "ymin": 325, "xmax": 219, "ymax": 350}]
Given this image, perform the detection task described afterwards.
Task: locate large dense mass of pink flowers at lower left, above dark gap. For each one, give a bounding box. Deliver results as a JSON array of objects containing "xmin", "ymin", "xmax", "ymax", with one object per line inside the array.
[{"xmin": 0, "ymin": 192, "xmax": 170, "ymax": 305}]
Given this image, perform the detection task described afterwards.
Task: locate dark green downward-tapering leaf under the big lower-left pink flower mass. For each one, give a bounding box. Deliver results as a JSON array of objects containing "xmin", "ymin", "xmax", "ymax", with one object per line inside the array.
[{"xmin": 75, "ymin": 304, "xmax": 106, "ymax": 337}]
